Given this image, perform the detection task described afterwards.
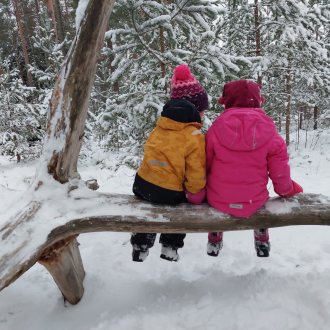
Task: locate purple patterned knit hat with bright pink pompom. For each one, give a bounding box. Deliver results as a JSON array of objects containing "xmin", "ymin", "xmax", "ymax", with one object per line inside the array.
[{"xmin": 171, "ymin": 64, "xmax": 209, "ymax": 111}]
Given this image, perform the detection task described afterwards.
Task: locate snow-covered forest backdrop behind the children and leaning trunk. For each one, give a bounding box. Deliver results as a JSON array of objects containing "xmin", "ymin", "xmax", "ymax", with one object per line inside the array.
[{"xmin": 0, "ymin": 0, "xmax": 330, "ymax": 167}]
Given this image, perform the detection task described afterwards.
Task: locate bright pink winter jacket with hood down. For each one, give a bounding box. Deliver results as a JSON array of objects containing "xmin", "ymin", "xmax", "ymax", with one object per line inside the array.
[{"xmin": 206, "ymin": 108, "xmax": 292, "ymax": 217}]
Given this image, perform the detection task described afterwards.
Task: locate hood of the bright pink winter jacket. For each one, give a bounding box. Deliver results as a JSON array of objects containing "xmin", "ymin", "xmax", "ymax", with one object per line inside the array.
[{"xmin": 214, "ymin": 108, "xmax": 276, "ymax": 151}]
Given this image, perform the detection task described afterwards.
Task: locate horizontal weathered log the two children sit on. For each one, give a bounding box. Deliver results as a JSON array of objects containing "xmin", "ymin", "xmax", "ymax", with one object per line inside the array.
[{"xmin": 48, "ymin": 194, "xmax": 330, "ymax": 240}]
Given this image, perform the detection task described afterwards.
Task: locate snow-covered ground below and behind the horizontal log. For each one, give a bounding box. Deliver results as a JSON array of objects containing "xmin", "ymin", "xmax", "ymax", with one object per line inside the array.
[{"xmin": 0, "ymin": 132, "xmax": 330, "ymax": 330}]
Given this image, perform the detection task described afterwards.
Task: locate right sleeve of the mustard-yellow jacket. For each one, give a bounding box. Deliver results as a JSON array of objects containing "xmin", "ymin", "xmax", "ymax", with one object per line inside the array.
[{"xmin": 184, "ymin": 133, "xmax": 206, "ymax": 194}]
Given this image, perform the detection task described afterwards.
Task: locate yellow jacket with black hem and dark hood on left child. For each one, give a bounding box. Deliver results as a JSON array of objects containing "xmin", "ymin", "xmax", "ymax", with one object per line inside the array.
[{"xmin": 133, "ymin": 99, "xmax": 206, "ymax": 204}]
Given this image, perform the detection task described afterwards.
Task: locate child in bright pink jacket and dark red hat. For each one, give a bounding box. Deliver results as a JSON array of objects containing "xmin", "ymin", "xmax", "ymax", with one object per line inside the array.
[{"xmin": 206, "ymin": 80, "xmax": 303, "ymax": 257}]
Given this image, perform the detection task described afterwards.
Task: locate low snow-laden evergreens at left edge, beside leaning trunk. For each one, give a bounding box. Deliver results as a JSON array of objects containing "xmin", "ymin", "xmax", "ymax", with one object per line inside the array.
[{"xmin": 0, "ymin": 54, "xmax": 46, "ymax": 162}]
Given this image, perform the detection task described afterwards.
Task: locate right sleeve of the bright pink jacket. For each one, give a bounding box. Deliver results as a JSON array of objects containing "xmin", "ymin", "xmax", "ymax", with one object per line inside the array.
[{"xmin": 267, "ymin": 133, "xmax": 292, "ymax": 195}]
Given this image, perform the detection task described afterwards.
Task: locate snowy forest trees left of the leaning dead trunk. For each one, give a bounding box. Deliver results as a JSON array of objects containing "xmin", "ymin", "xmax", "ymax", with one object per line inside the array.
[{"xmin": 0, "ymin": 0, "xmax": 74, "ymax": 160}]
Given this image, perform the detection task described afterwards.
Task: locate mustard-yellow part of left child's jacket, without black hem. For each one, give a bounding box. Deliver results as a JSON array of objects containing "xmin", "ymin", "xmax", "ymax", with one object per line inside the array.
[{"xmin": 138, "ymin": 117, "xmax": 206, "ymax": 193}]
